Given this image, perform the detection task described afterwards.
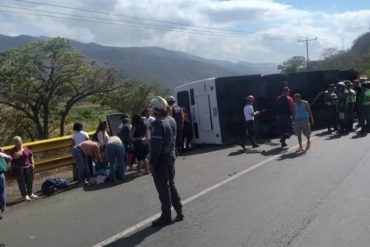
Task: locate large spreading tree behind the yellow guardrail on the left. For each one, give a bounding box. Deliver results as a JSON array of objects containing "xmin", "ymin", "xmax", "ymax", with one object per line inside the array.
[{"xmin": 0, "ymin": 38, "xmax": 117, "ymax": 138}]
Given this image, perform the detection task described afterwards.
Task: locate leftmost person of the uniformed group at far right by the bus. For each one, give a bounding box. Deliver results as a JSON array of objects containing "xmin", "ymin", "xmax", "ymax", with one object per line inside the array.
[{"xmin": 324, "ymin": 84, "xmax": 338, "ymax": 133}]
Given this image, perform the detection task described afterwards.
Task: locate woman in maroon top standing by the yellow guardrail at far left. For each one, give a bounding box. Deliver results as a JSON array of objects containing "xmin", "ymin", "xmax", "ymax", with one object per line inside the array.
[{"xmin": 10, "ymin": 136, "xmax": 38, "ymax": 201}]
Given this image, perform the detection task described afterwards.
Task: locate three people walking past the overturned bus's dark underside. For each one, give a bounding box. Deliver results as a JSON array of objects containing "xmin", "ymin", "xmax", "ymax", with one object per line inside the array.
[{"xmin": 240, "ymin": 87, "xmax": 314, "ymax": 152}]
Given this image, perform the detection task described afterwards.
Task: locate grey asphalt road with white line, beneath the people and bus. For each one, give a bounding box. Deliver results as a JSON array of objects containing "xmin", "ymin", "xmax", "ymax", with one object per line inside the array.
[{"xmin": 0, "ymin": 132, "xmax": 370, "ymax": 247}]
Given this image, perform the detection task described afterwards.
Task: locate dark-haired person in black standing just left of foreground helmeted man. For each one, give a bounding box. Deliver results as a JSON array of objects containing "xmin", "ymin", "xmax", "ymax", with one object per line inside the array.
[{"xmin": 131, "ymin": 114, "xmax": 149, "ymax": 174}]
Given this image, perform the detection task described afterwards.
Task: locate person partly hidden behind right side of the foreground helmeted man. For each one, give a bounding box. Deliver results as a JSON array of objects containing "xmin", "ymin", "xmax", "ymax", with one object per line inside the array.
[{"xmin": 167, "ymin": 96, "xmax": 184, "ymax": 154}]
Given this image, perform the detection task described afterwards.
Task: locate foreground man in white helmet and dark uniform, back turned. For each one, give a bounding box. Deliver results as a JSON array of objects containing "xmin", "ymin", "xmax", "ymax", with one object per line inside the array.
[{"xmin": 149, "ymin": 96, "xmax": 184, "ymax": 227}]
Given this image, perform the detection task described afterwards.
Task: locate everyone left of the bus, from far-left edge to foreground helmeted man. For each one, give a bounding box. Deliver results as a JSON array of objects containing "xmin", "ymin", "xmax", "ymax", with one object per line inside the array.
[{"xmin": 0, "ymin": 96, "xmax": 184, "ymax": 226}]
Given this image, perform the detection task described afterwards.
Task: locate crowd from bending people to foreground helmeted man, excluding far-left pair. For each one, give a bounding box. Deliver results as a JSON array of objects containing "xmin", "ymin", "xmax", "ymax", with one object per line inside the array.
[{"xmin": 72, "ymin": 96, "xmax": 184, "ymax": 226}]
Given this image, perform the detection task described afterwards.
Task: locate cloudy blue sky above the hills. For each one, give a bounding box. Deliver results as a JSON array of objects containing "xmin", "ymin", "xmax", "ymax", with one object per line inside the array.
[{"xmin": 0, "ymin": 0, "xmax": 370, "ymax": 63}]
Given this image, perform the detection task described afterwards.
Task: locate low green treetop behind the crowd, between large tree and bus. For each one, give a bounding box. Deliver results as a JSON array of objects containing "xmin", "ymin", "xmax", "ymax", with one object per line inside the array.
[{"xmin": 99, "ymin": 81, "xmax": 168, "ymax": 115}]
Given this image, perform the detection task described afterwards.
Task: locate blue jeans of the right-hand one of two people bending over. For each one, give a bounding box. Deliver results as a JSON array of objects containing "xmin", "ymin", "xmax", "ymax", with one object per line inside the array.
[{"xmin": 105, "ymin": 143, "xmax": 126, "ymax": 181}]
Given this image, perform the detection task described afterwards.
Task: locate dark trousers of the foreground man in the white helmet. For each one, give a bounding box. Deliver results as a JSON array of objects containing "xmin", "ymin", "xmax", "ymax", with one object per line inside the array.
[{"xmin": 153, "ymin": 157, "xmax": 182, "ymax": 219}]
